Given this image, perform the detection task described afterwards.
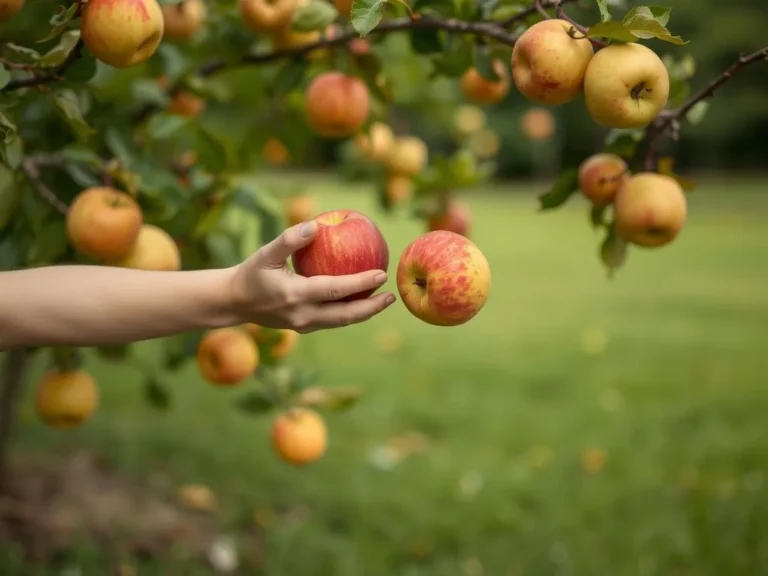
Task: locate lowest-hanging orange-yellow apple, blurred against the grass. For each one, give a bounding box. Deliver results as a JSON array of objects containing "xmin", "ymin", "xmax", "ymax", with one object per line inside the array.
[{"xmin": 271, "ymin": 407, "xmax": 328, "ymax": 465}]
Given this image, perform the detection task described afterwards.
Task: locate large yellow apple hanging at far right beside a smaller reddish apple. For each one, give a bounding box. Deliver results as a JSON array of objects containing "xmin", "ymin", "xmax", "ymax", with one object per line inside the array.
[{"xmin": 614, "ymin": 172, "xmax": 688, "ymax": 248}]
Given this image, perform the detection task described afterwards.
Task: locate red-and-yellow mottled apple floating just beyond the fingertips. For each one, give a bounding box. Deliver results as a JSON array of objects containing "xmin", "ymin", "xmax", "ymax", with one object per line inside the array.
[{"xmin": 397, "ymin": 230, "xmax": 491, "ymax": 326}]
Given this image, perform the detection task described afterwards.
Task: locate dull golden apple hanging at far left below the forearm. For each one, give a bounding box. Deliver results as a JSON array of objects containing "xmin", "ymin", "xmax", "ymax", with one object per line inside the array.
[{"xmin": 35, "ymin": 370, "xmax": 99, "ymax": 429}]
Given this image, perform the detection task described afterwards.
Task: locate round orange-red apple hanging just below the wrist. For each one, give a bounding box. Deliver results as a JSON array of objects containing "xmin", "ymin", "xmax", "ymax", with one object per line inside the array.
[{"xmin": 197, "ymin": 327, "xmax": 259, "ymax": 386}]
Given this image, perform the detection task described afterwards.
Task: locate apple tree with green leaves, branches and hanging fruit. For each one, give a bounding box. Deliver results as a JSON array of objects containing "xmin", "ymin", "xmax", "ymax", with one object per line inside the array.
[{"xmin": 0, "ymin": 0, "xmax": 768, "ymax": 488}]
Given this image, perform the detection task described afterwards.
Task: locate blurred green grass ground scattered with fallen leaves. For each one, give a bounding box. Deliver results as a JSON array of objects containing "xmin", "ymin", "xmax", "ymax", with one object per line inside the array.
[{"xmin": 7, "ymin": 176, "xmax": 768, "ymax": 576}]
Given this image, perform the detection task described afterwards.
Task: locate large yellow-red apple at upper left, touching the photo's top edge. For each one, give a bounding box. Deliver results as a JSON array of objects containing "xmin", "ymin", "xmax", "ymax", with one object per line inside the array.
[{"xmin": 80, "ymin": 0, "xmax": 165, "ymax": 68}]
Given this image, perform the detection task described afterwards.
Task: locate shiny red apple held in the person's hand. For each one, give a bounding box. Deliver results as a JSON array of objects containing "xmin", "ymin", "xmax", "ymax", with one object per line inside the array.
[{"xmin": 291, "ymin": 210, "xmax": 389, "ymax": 302}]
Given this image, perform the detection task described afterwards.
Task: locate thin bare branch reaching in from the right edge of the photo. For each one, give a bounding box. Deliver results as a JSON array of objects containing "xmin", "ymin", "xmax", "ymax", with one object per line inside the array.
[{"xmin": 644, "ymin": 46, "xmax": 768, "ymax": 170}]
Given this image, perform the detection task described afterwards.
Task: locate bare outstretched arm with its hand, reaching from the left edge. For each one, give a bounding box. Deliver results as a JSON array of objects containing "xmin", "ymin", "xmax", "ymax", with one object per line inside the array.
[{"xmin": 0, "ymin": 222, "xmax": 394, "ymax": 350}]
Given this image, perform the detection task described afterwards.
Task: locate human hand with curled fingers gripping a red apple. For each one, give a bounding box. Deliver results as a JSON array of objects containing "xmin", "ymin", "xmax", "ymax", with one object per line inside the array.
[{"xmin": 226, "ymin": 220, "xmax": 395, "ymax": 334}]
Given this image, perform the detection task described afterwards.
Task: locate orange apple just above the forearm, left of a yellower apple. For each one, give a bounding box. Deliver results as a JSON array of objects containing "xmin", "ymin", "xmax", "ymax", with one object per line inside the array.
[{"xmin": 66, "ymin": 186, "xmax": 144, "ymax": 261}]
